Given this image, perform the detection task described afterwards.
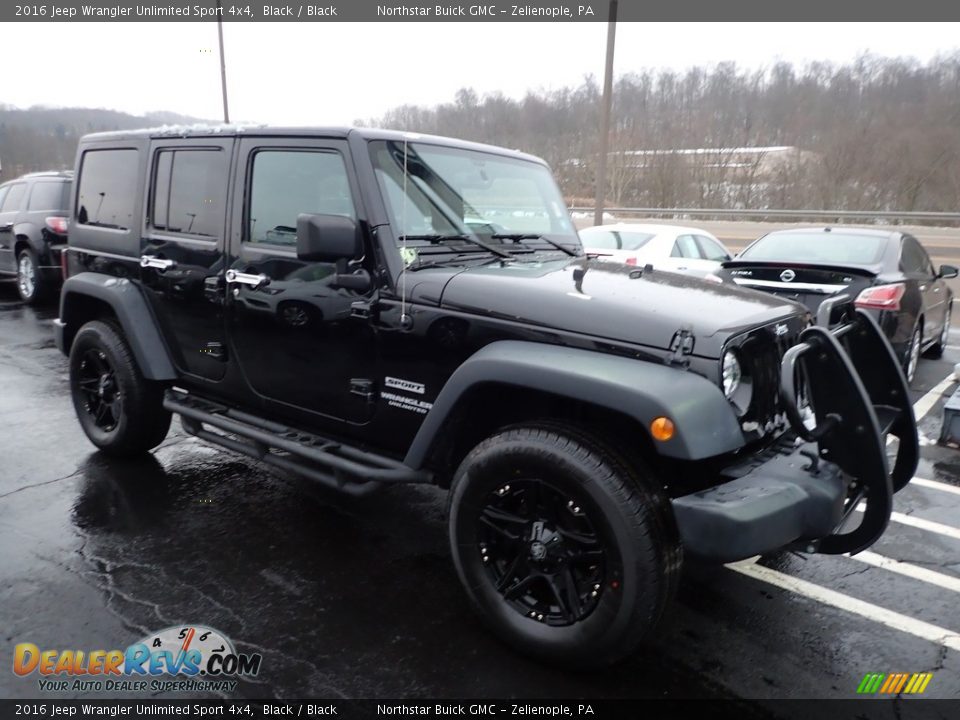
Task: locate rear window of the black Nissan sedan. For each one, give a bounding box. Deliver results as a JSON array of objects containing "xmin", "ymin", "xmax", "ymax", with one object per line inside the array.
[{"xmin": 737, "ymin": 232, "xmax": 887, "ymax": 265}]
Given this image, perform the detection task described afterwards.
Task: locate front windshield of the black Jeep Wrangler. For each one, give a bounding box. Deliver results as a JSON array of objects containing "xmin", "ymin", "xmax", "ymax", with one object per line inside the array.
[{"xmin": 370, "ymin": 140, "xmax": 580, "ymax": 250}]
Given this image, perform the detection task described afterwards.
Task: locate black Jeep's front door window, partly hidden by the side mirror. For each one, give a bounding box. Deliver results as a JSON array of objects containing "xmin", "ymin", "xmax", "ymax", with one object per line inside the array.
[{"xmin": 246, "ymin": 149, "xmax": 356, "ymax": 247}]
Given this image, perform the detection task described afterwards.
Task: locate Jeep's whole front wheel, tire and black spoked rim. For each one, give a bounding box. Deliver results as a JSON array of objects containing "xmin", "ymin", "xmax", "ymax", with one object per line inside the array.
[{"xmin": 450, "ymin": 425, "xmax": 681, "ymax": 667}]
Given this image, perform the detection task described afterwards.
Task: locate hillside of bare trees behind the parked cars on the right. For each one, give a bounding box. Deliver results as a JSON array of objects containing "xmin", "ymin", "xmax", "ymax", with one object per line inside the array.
[{"xmin": 368, "ymin": 53, "xmax": 960, "ymax": 212}]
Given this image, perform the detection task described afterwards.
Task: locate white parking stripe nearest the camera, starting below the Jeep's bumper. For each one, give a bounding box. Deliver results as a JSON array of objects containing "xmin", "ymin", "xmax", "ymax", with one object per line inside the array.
[{"xmin": 727, "ymin": 559, "xmax": 960, "ymax": 651}]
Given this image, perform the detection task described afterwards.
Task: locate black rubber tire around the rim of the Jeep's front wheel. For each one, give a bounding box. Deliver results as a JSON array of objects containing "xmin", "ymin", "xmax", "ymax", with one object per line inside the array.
[{"xmin": 449, "ymin": 423, "xmax": 682, "ymax": 668}]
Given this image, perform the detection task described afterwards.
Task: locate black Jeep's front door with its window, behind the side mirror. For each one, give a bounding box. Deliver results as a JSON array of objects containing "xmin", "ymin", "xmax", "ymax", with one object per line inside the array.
[{"xmin": 227, "ymin": 138, "xmax": 377, "ymax": 425}]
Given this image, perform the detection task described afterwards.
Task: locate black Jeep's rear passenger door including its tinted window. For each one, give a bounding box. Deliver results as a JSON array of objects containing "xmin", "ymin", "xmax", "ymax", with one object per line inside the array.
[{"xmin": 141, "ymin": 138, "xmax": 234, "ymax": 381}]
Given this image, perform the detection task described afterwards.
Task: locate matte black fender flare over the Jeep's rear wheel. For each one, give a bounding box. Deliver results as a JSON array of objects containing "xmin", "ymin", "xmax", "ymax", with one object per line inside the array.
[{"xmin": 57, "ymin": 272, "xmax": 177, "ymax": 380}]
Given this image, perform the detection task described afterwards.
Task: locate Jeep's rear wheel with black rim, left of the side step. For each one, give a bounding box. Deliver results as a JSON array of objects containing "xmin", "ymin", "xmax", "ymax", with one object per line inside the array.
[{"xmin": 70, "ymin": 320, "xmax": 170, "ymax": 457}]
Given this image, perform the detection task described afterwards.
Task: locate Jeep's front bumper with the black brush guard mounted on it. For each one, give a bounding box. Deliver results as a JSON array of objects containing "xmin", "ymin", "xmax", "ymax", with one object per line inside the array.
[{"xmin": 673, "ymin": 310, "xmax": 919, "ymax": 562}]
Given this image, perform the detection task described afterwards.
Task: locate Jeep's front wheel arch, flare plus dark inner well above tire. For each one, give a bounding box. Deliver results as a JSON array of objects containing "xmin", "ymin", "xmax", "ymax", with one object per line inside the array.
[{"xmin": 404, "ymin": 340, "xmax": 744, "ymax": 476}]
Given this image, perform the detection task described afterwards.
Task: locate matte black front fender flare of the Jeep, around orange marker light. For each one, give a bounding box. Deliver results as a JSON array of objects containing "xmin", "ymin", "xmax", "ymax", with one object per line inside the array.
[{"xmin": 404, "ymin": 340, "xmax": 744, "ymax": 469}]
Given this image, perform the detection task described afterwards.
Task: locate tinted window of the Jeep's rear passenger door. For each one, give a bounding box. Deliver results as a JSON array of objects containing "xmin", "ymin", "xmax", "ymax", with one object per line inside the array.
[{"xmin": 150, "ymin": 148, "xmax": 227, "ymax": 238}]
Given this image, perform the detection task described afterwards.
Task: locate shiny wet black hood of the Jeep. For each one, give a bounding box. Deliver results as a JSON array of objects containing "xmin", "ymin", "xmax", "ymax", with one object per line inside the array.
[{"xmin": 424, "ymin": 258, "xmax": 806, "ymax": 358}]
